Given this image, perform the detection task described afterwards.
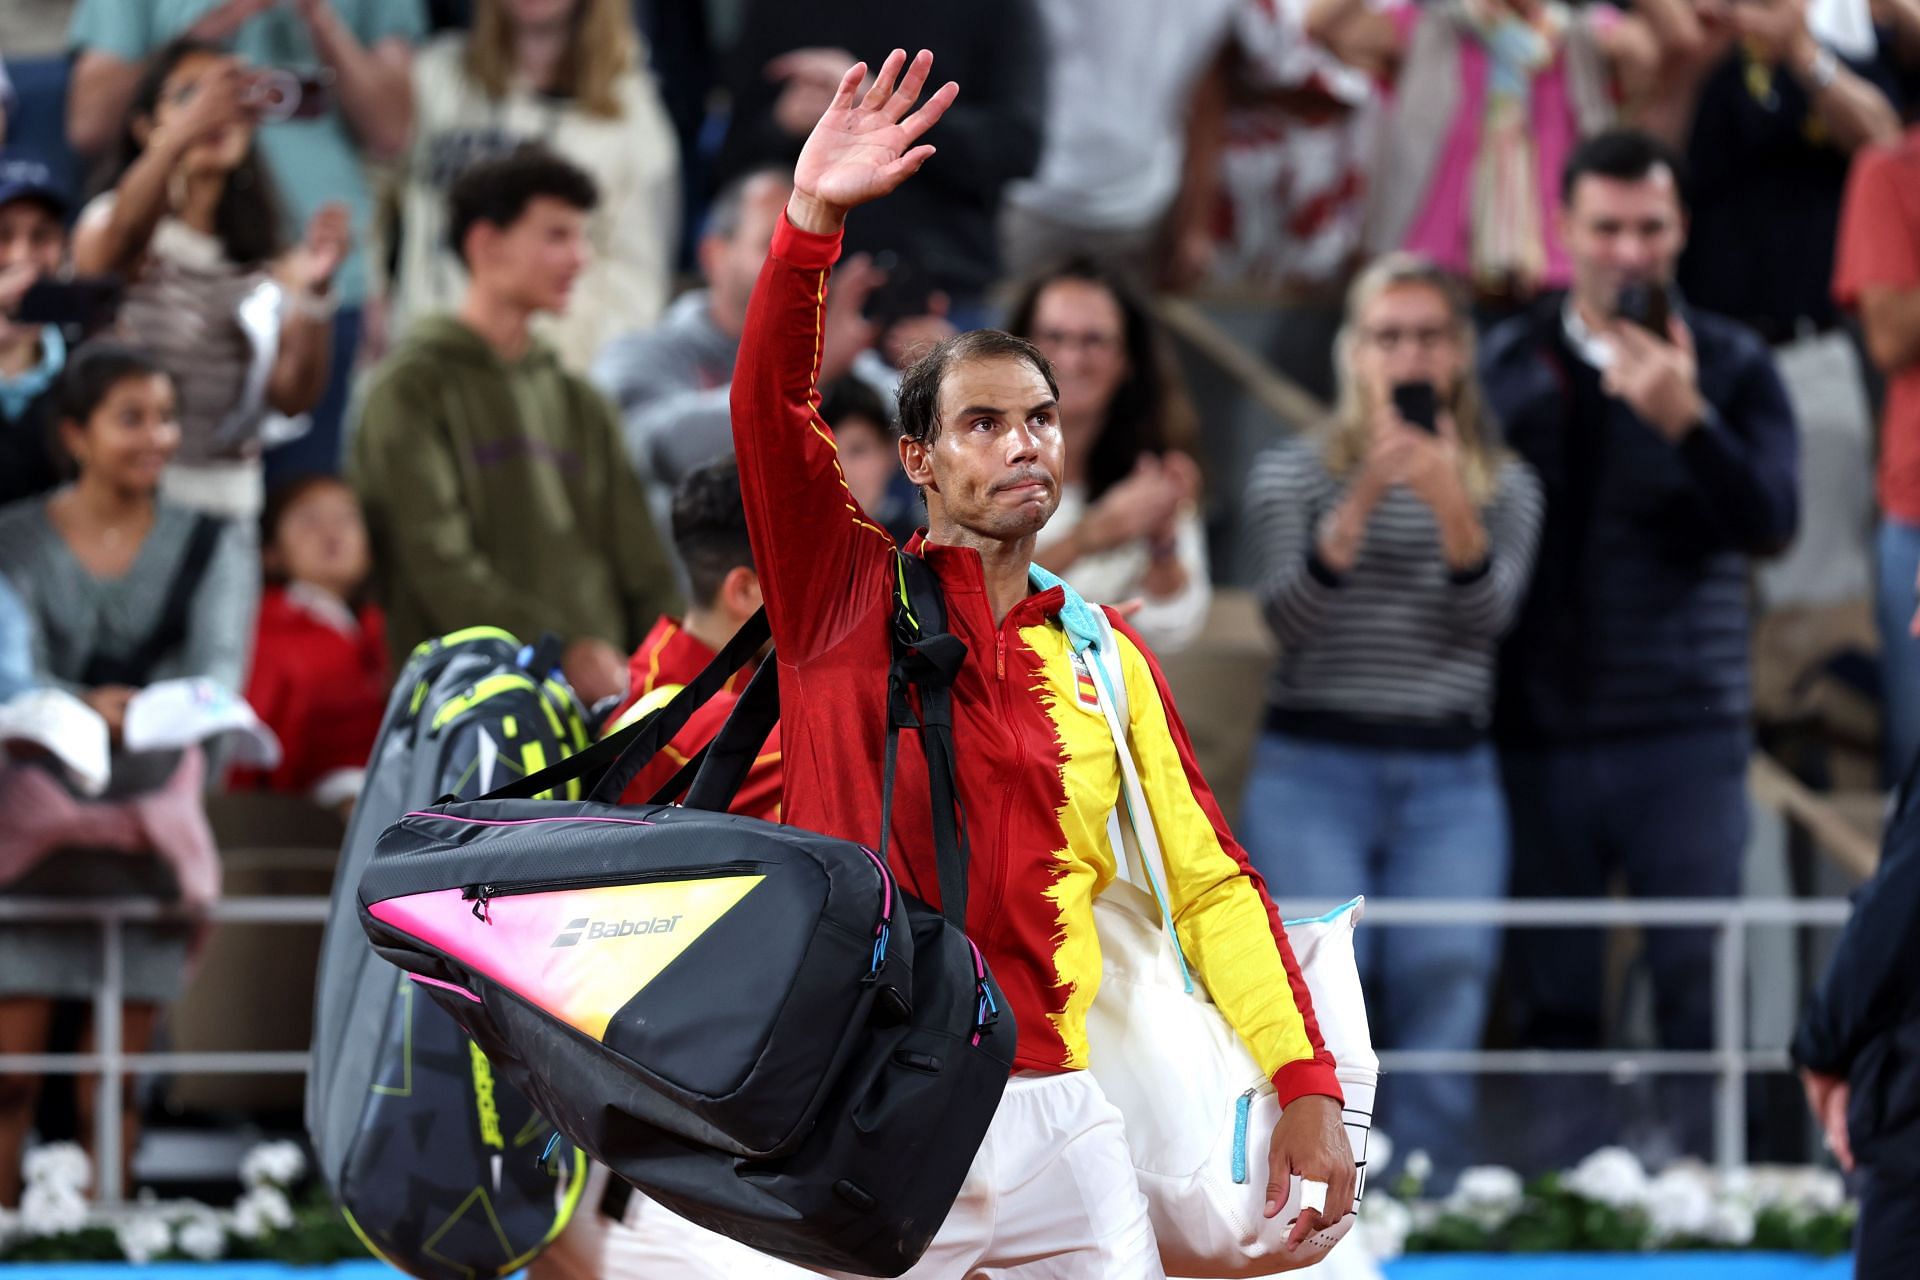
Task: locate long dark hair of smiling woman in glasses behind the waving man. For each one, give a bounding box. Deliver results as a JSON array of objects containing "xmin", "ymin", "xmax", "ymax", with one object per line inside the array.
[{"xmin": 1006, "ymin": 255, "xmax": 1198, "ymax": 501}]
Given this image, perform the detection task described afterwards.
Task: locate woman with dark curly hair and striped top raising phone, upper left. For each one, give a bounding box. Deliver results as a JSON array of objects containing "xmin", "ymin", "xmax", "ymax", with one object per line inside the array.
[{"xmin": 73, "ymin": 40, "xmax": 348, "ymax": 524}]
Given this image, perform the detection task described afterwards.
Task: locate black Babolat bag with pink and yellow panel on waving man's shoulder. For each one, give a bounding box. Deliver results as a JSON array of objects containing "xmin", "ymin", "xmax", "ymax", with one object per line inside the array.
[{"xmin": 359, "ymin": 557, "xmax": 1014, "ymax": 1276}]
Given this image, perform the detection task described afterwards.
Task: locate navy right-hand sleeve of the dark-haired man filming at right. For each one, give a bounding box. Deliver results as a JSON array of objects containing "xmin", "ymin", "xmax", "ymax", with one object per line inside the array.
[{"xmin": 1680, "ymin": 340, "xmax": 1799, "ymax": 555}]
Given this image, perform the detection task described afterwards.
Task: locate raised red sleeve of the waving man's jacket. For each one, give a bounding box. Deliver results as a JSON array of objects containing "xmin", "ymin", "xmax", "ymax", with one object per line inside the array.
[{"xmin": 733, "ymin": 215, "xmax": 893, "ymax": 666}]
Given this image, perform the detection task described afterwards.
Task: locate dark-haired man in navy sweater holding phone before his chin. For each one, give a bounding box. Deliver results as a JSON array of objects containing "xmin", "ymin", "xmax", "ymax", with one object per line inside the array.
[{"xmin": 1480, "ymin": 130, "xmax": 1799, "ymax": 1167}]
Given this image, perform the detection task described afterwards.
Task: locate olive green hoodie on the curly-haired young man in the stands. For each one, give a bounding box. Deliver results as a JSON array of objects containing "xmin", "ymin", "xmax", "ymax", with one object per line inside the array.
[{"xmin": 349, "ymin": 315, "xmax": 680, "ymax": 670}]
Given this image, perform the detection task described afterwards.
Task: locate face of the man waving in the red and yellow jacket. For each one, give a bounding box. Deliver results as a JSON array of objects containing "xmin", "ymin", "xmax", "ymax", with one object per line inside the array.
[{"xmin": 900, "ymin": 355, "xmax": 1064, "ymax": 541}]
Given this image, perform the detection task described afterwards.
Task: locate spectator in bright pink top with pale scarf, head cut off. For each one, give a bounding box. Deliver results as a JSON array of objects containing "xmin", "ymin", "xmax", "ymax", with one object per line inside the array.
[{"xmin": 1306, "ymin": 0, "xmax": 1684, "ymax": 315}]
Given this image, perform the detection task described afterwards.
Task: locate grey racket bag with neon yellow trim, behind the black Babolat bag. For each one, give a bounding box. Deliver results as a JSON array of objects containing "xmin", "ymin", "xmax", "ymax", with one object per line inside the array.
[{"xmin": 307, "ymin": 628, "xmax": 588, "ymax": 1280}]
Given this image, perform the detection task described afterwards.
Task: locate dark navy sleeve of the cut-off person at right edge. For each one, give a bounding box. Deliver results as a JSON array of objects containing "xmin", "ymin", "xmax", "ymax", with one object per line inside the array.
[{"xmin": 1793, "ymin": 779, "xmax": 1920, "ymax": 1075}]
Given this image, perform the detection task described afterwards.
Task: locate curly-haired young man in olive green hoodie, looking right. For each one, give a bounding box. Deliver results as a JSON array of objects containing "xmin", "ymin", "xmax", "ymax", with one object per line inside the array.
[{"xmin": 353, "ymin": 148, "xmax": 674, "ymax": 704}]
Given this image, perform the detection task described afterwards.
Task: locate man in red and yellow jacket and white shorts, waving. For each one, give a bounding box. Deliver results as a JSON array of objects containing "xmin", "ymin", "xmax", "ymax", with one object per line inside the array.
[{"xmin": 733, "ymin": 50, "xmax": 1354, "ymax": 1280}]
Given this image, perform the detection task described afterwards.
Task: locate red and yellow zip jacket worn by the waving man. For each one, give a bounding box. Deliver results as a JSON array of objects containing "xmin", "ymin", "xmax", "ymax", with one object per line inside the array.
[{"xmin": 733, "ymin": 219, "xmax": 1340, "ymax": 1105}]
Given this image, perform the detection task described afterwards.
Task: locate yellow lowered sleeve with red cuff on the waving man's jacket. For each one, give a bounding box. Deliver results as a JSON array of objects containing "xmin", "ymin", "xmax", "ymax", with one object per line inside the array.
[{"xmin": 1108, "ymin": 610, "xmax": 1342, "ymax": 1107}]
